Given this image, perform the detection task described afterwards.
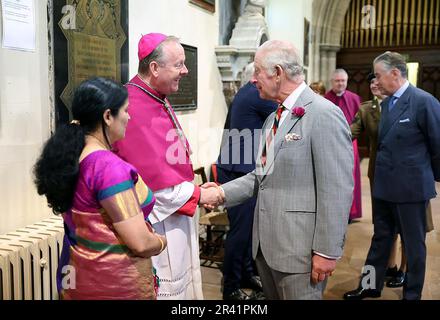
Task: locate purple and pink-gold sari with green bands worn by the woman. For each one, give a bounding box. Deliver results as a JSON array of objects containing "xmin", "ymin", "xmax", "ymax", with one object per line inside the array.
[{"xmin": 57, "ymin": 150, "xmax": 156, "ymax": 300}]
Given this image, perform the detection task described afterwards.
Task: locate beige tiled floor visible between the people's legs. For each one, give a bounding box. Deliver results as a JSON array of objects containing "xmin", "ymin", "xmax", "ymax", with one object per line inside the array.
[{"xmin": 202, "ymin": 159, "xmax": 440, "ymax": 300}]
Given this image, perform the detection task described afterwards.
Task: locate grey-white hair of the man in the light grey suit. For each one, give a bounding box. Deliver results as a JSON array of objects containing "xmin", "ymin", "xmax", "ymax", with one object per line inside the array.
[{"xmin": 258, "ymin": 40, "xmax": 304, "ymax": 80}]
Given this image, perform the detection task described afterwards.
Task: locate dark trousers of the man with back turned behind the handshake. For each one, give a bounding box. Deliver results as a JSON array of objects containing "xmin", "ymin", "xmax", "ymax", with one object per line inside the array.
[{"xmin": 217, "ymin": 167, "xmax": 256, "ymax": 294}]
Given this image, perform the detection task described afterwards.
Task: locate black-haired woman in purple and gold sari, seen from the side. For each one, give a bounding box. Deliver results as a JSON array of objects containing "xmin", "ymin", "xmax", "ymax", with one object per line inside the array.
[{"xmin": 34, "ymin": 78, "xmax": 167, "ymax": 299}]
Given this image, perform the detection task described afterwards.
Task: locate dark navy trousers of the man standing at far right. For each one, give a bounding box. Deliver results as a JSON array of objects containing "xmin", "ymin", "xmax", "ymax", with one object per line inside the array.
[{"xmin": 365, "ymin": 198, "xmax": 428, "ymax": 300}]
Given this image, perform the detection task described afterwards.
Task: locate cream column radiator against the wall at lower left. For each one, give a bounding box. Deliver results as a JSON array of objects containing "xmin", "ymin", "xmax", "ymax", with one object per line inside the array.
[{"xmin": 0, "ymin": 217, "xmax": 64, "ymax": 300}]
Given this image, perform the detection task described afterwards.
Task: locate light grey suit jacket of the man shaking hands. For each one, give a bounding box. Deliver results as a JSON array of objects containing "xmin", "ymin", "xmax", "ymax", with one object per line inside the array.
[{"xmin": 222, "ymin": 87, "xmax": 354, "ymax": 273}]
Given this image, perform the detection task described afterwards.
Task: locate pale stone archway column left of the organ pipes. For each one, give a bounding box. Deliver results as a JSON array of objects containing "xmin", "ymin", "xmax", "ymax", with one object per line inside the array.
[{"xmin": 309, "ymin": 0, "xmax": 351, "ymax": 87}]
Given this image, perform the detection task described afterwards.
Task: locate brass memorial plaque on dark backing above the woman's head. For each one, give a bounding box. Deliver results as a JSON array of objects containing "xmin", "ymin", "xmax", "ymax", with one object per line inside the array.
[{"xmin": 53, "ymin": 0, "xmax": 128, "ymax": 125}]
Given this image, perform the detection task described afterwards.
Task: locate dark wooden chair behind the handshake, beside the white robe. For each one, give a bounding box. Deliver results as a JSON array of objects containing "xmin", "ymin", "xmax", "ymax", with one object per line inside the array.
[{"xmin": 194, "ymin": 167, "xmax": 229, "ymax": 268}]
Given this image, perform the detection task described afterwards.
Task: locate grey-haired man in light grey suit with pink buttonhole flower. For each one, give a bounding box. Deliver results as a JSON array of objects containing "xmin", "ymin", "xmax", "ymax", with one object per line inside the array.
[{"xmin": 205, "ymin": 40, "xmax": 354, "ymax": 299}]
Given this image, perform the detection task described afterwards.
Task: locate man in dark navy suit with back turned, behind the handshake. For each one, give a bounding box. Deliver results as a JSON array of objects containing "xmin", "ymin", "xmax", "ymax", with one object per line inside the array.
[{"xmin": 217, "ymin": 63, "xmax": 277, "ymax": 300}]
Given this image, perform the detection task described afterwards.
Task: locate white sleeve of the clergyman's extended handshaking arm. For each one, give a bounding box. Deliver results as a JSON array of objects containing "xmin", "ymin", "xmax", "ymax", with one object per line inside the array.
[{"xmin": 148, "ymin": 181, "xmax": 194, "ymax": 224}]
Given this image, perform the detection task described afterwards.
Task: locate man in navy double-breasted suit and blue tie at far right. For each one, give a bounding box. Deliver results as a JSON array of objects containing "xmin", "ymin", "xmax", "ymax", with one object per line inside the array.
[{"xmin": 344, "ymin": 51, "xmax": 440, "ymax": 300}]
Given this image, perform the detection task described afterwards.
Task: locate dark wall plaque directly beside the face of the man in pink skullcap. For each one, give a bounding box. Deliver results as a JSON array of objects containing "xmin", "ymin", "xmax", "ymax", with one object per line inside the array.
[{"xmin": 168, "ymin": 44, "xmax": 197, "ymax": 111}]
